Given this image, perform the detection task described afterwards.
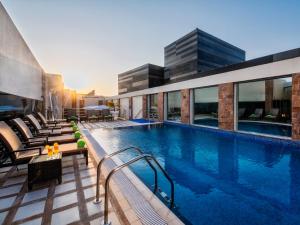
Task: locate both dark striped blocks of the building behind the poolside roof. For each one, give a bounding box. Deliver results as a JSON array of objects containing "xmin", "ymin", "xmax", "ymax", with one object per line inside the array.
[{"xmin": 118, "ymin": 28, "xmax": 245, "ymax": 94}]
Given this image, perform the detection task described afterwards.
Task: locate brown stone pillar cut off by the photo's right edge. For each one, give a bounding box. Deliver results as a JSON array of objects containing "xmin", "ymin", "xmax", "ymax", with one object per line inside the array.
[{"xmin": 292, "ymin": 73, "xmax": 300, "ymax": 140}]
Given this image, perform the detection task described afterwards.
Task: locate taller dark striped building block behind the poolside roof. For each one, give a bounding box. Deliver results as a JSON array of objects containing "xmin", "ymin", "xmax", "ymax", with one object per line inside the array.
[{"xmin": 165, "ymin": 28, "xmax": 245, "ymax": 83}]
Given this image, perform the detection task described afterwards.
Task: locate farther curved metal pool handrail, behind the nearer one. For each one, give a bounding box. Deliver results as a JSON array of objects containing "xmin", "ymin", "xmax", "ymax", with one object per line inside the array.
[{"xmin": 94, "ymin": 146, "xmax": 158, "ymax": 204}]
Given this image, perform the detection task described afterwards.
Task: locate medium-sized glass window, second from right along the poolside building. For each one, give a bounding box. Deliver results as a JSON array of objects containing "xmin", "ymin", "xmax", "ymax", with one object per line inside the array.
[{"xmin": 194, "ymin": 87, "xmax": 218, "ymax": 127}]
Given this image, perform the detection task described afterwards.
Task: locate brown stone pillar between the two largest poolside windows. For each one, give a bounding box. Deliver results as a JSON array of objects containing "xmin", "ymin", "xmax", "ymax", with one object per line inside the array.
[{"xmin": 218, "ymin": 83, "xmax": 234, "ymax": 130}]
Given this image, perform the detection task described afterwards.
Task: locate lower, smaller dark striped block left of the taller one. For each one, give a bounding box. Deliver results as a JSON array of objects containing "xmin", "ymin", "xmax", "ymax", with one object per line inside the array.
[{"xmin": 118, "ymin": 64, "xmax": 164, "ymax": 94}]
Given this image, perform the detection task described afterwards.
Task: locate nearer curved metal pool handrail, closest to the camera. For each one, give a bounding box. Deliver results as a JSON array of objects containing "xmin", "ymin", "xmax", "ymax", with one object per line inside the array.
[{"xmin": 104, "ymin": 154, "xmax": 174, "ymax": 225}]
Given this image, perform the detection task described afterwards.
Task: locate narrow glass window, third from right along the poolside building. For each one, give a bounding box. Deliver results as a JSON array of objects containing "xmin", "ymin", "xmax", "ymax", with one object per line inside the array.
[{"xmin": 167, "ymin": 91, "xmax": 181, "ymax": 121}]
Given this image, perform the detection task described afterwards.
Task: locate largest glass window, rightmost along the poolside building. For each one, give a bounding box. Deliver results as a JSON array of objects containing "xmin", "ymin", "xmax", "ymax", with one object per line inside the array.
[{"xmin": 237, "ymin": 77, "xmax": 292, "ymax": 136}]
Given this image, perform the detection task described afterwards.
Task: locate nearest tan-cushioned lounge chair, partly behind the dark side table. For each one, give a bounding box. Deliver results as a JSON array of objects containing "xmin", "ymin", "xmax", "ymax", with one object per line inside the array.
[{"xmin": 0, "ymin": 121, "xmax": 88, "ymax": 165}]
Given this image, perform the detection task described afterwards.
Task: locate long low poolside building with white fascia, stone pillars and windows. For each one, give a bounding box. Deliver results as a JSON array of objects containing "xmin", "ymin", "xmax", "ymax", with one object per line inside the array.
[{"xmin": 108, "ymin": 48, "xmax": 300, "ymax": 140}]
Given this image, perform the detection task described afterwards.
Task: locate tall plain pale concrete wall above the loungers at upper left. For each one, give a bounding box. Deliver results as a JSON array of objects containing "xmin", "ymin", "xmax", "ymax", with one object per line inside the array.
[{"xmin": 0, "ymin": 3, "xmax": 43, "ymax": 100}]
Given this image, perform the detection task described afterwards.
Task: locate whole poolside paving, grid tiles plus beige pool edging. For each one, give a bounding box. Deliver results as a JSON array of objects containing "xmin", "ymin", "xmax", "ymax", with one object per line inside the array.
[{"xmin": 0, "ymin": 124, "xmax": 183, "ymax": 225}]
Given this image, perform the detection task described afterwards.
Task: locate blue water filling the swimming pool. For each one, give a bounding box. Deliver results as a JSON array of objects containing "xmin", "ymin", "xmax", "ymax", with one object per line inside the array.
[{"xmin": 92, "ymin": 125, "xmax": 300, "ymax": 225}]
